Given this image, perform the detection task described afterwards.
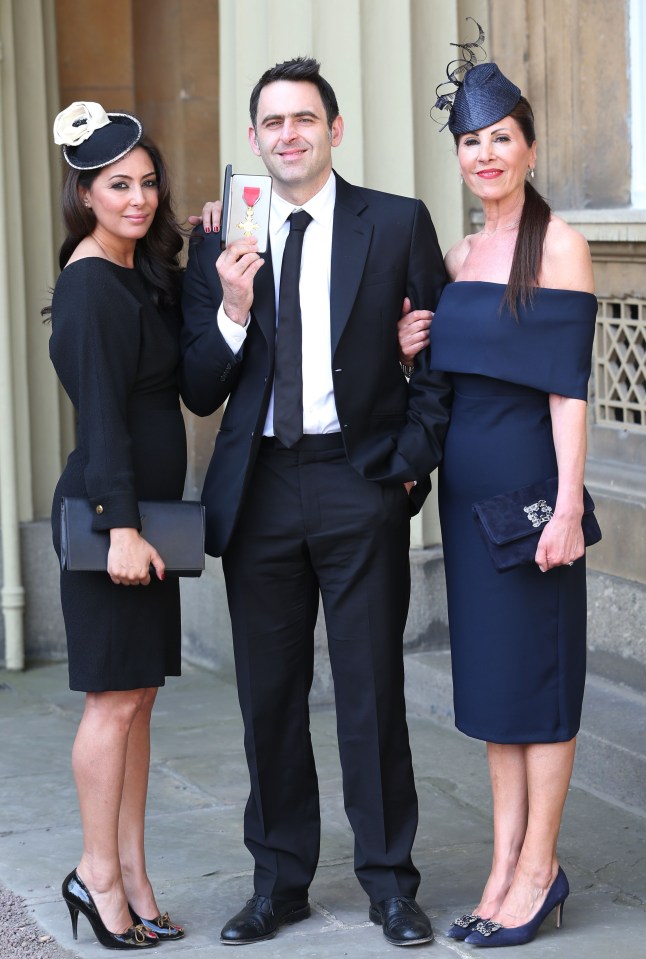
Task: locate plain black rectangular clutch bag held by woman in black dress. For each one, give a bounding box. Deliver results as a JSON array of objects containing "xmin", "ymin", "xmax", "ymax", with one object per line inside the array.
[{"xmin": 61, "ymin": 496, "xmax": 204, "ymax": 576}]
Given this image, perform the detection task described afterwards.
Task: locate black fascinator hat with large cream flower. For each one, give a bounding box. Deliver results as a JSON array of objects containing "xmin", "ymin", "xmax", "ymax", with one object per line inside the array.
[{"xmin": 54, "ymin": 100, "xmax": 144, "ymax": 170}]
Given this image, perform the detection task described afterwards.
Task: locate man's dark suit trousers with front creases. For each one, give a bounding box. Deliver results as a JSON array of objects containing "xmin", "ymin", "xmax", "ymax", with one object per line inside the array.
[{"xmin": 223, "ymin": 436, "xmax": 419, "ymax": 901}]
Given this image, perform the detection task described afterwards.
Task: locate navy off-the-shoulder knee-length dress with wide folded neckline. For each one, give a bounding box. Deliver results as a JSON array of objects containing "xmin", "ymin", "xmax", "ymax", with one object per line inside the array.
[{"xmin": 431, "ymin": 282, "xmax": 597, "ymax": 743}]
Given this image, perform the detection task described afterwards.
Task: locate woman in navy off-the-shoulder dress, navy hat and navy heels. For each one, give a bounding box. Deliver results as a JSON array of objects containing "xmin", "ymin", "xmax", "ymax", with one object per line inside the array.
[{"xmin": 400, "ymin": 28, "xmax": 596, "ymax": 947}]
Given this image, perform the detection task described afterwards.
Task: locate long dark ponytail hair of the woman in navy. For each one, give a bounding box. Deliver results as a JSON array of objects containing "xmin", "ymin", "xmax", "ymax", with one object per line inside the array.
[{"xmin": 455, "ymin": 97, "xmax": 551, "ymax": 320}]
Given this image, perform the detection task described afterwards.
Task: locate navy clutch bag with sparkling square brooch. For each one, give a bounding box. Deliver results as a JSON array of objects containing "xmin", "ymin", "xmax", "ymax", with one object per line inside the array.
[{"xmin": 472, "ymin": 476, "xmax": 601, "ymax": 573}]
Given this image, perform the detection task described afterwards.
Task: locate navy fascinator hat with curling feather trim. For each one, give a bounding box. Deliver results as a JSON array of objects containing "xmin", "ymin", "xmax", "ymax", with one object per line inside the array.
[{"xmin": 431, "ymin": 17, "xmax": 521, "ymax": 136}]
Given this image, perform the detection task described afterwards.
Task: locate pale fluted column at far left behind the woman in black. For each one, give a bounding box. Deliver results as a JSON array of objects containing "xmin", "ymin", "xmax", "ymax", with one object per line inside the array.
[{"xmin": 0, "ymin": 0, "xmax": 61, "ymax": 521}]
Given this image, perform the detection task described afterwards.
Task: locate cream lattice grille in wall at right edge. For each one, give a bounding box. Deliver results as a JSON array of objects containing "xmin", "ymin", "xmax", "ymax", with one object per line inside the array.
[{"xmin": 595, "ymin": 299, "xmax": 646, "ymax": 433}]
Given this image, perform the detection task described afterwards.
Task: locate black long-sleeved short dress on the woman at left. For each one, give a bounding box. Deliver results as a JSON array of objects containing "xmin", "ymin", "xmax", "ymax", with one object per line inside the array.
[{"xmin": 50, "ymin": 257, "xmax": 186, "ymax": 692}]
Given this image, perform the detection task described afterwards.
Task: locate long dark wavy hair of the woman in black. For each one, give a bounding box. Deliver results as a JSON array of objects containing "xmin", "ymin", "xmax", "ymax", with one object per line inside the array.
[{"xmin": 41, "ymin": 136, "xmax": 184, "ymax": 317}]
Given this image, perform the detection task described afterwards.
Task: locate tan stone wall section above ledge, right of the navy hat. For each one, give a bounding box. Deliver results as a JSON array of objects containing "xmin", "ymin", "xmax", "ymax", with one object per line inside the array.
[{"xmin": 488, "ymin": 0, "xmax": 631, "ymax": 210}]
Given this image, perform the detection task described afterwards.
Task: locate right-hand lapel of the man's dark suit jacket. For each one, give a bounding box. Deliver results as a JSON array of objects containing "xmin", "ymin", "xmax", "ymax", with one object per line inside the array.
[{"xmin": 330, "ymin": 174, "xmax": 373, "ymax": 356}]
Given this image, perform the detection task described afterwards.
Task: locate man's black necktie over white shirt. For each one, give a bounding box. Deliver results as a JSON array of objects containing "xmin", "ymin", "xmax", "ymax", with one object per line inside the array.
[{"xmin": 274, "ymin": 210, "xmax": 312, "ymax": 446}]
